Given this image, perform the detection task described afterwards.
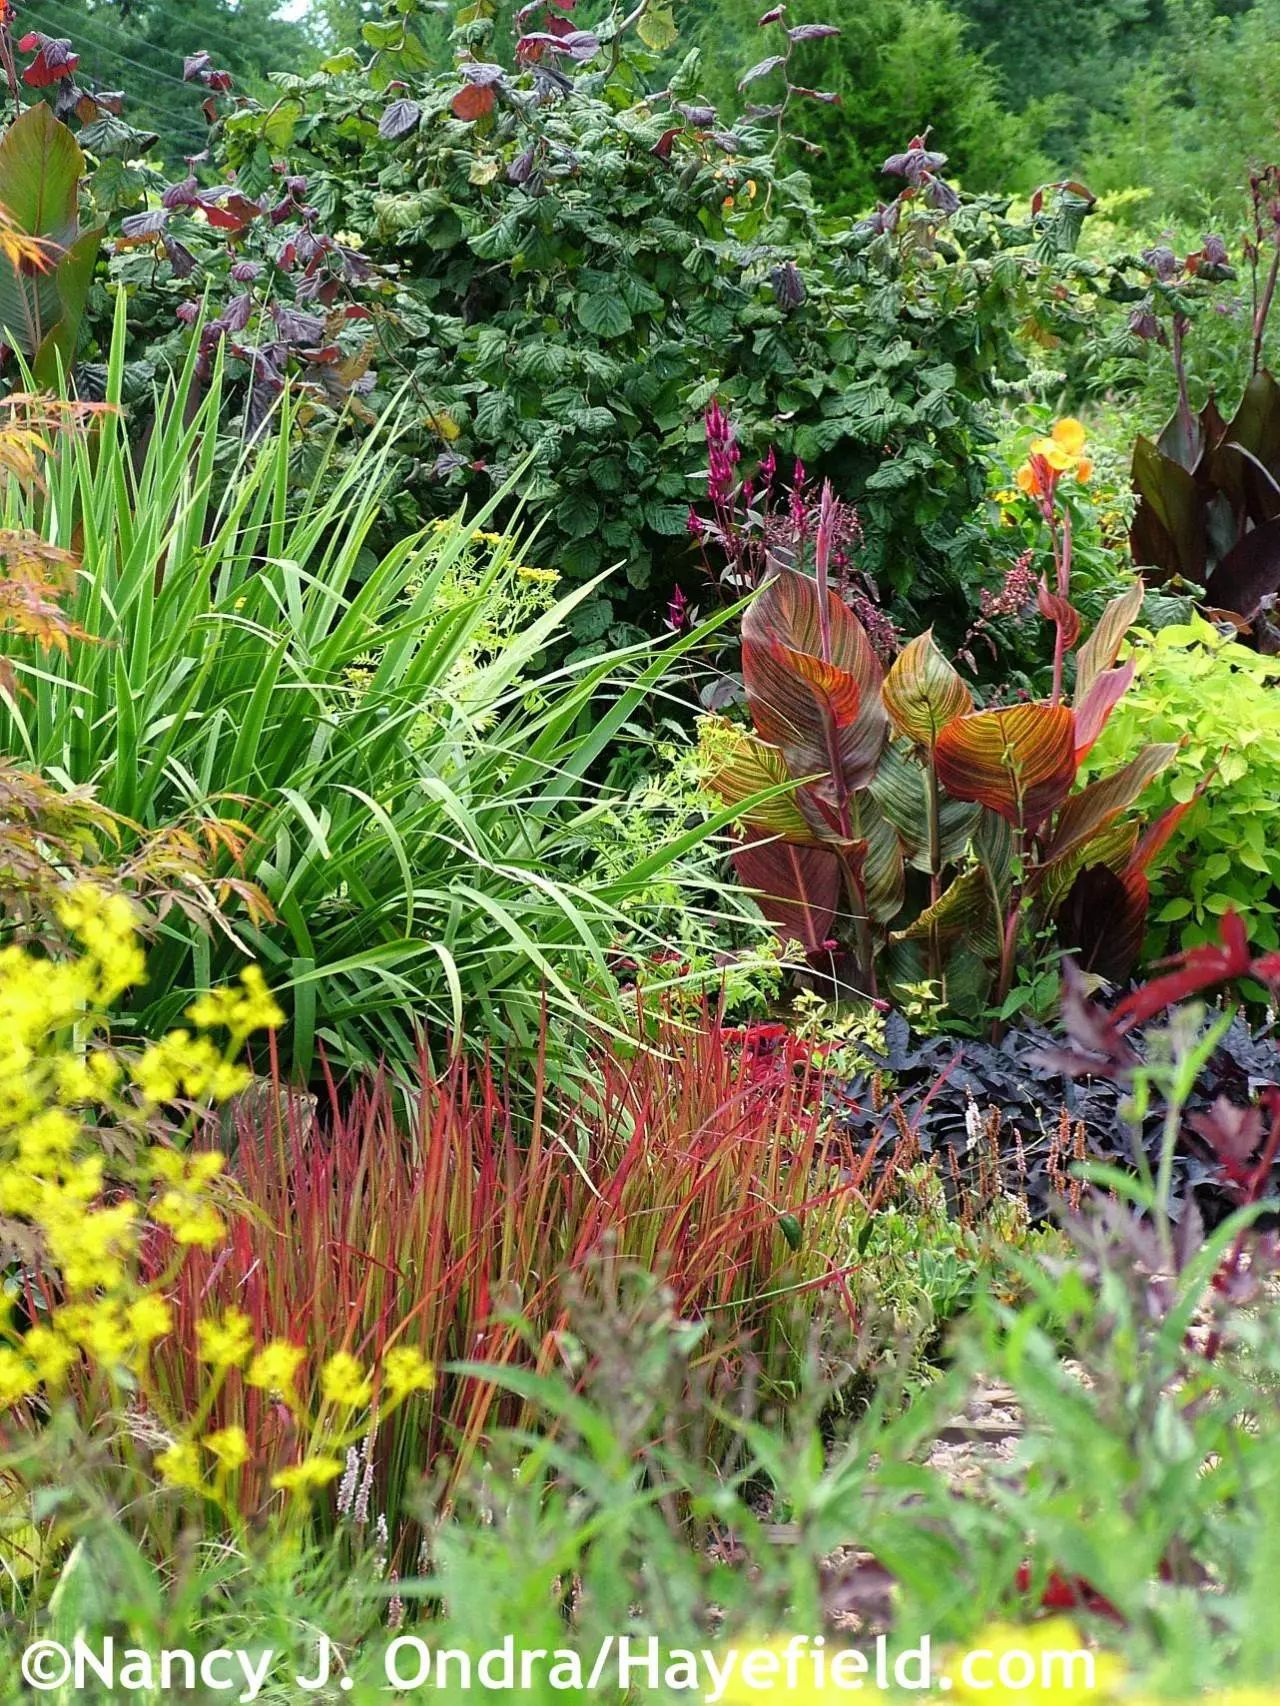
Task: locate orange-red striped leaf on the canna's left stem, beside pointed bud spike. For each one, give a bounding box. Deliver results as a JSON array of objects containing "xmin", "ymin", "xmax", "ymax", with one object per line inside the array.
[{"xmin": 742, "ymin": 640, "xmax": 889, "ymax": 800}]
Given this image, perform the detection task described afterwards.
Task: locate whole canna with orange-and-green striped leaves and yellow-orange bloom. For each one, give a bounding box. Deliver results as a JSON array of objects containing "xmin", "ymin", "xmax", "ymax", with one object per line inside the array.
[{"xmin": 708, "ymin": 421, "xmax": 1186, "ymax": 1025}]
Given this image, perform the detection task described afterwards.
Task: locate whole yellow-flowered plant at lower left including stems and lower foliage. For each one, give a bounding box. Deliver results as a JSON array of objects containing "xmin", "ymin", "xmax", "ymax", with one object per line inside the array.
[{"xmin": 0, "ymin": 884, "xmax": 432, "ymax": 1575}]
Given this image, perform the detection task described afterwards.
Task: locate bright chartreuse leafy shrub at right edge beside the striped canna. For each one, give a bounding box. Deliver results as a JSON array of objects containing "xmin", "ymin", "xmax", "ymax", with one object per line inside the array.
[{"xmin": 1089, "ymin": 616, "xmax": 1280, "ymax": 955}]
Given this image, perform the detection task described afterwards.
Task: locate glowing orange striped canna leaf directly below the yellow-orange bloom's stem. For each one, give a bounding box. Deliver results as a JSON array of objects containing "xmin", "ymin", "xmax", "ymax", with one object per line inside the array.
[{"xmin": 934, "ymin": 705, "xmax": 1077, "ymax": 829}]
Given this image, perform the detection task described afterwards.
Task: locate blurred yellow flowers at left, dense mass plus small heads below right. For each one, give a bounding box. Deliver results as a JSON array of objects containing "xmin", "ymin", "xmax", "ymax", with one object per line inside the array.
[{"xmin": 0, "ymin": 887, "xmax": 435, "ymax": 1513}]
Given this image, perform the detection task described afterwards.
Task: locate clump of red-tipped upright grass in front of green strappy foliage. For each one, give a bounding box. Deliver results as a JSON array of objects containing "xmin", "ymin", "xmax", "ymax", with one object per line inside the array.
[{"xmin": 138, "ymin": 1013, "xmax": 874, "ymax": 1513}]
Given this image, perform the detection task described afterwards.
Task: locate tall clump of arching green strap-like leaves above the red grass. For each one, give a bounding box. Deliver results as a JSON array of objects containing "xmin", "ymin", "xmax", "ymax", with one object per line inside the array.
[{"xmin": 0, "ymin": 322, "xmax": 757, "ymax": 1073}]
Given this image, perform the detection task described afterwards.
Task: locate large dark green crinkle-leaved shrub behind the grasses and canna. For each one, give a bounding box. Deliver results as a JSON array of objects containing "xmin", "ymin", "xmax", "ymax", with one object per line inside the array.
[{"xmin": 37, "ymin": 0, "xmax": 1153, "ymax": 652}]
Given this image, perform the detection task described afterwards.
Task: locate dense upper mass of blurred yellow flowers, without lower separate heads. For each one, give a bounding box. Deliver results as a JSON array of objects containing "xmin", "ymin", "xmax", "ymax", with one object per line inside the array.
[{"xmin": 0, "ymin": 884, "xmax": 283, "ymax": 1407}]
